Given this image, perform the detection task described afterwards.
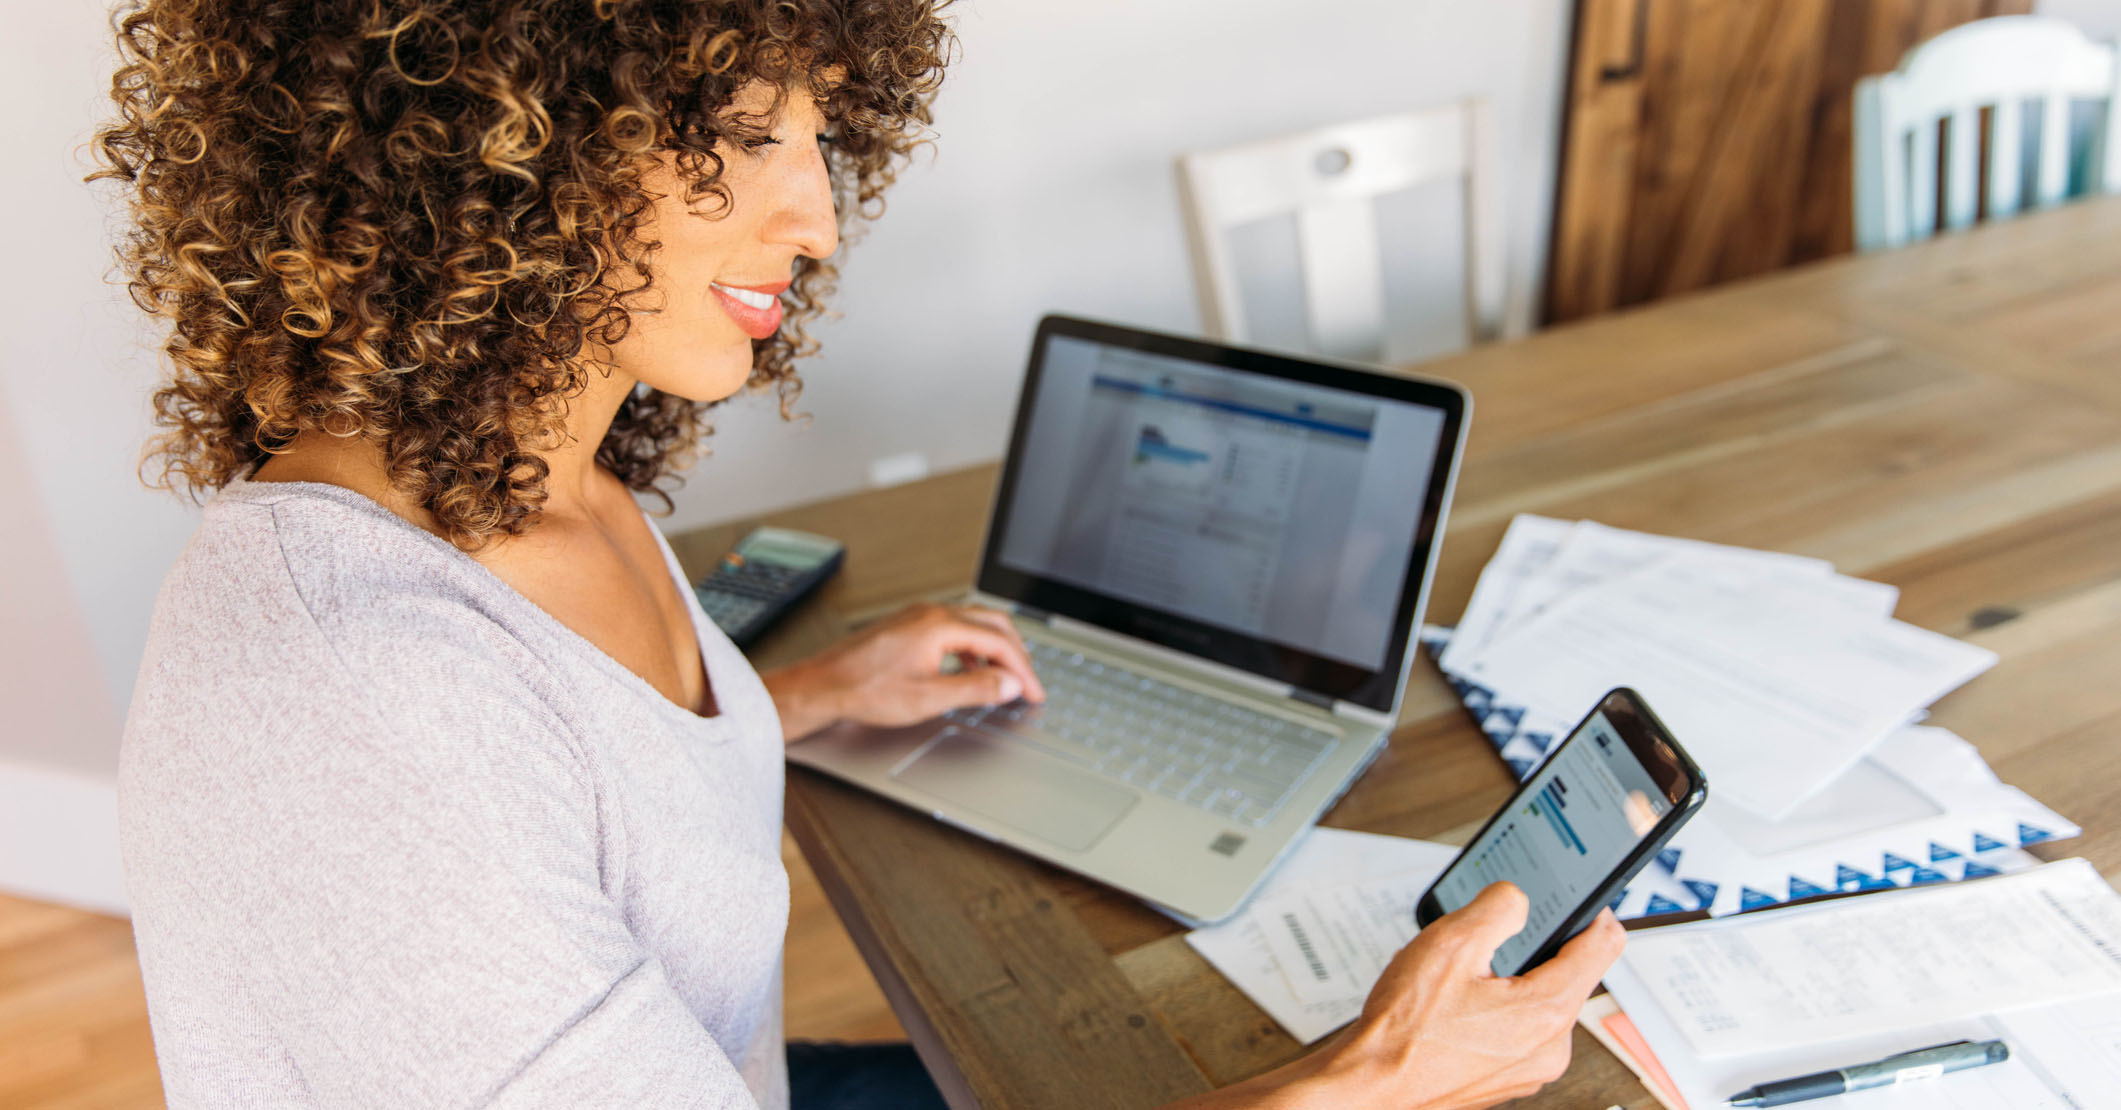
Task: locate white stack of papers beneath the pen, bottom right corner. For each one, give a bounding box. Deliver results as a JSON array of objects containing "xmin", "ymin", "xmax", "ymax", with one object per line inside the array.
[{"xmin": 1584, "ymin": 860, "xmax": 2121, "ymax": 1110}]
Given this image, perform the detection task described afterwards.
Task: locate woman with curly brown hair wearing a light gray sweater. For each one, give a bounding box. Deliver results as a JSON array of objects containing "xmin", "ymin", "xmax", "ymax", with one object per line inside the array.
[{"xmin": 100, "ymin": 0, "xmax": 1620, "ymax": 1108}]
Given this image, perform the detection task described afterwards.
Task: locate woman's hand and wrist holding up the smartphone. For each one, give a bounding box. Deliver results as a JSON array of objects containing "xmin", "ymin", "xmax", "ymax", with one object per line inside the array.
[{"xmin": 1179, "ymin": 883, "xmax": 1627, "ymax": 1110}]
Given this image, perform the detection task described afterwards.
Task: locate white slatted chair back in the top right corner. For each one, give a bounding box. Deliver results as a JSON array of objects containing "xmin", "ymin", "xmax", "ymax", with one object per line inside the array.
[{"xmin": 1856, "ymin": 15, "xmax": 2121, "ymax": 250}]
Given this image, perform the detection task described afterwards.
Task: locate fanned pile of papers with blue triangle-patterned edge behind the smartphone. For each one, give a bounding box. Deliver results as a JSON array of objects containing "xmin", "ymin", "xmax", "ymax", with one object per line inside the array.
[{"xmin": 1423, "ymin": 516, "xmax": 2079, "ymax": 917}]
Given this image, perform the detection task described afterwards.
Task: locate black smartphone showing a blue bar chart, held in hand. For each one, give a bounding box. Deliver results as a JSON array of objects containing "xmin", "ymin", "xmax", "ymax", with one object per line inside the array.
[{"xmin": 1415, "ymin": 686, "xmax": 1710, "ymax": 976}]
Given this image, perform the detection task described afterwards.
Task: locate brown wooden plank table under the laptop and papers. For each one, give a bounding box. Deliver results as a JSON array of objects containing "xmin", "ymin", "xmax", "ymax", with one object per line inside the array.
[{"xmin": 679, "ymin": 200, "xmax": 2121, "ymax": 1110}]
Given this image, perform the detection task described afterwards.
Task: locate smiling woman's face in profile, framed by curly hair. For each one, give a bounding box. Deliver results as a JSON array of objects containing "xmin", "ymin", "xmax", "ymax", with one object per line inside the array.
[{"xmin": 609, "ymin": 83, "xmax": 840, "ymax": 401}]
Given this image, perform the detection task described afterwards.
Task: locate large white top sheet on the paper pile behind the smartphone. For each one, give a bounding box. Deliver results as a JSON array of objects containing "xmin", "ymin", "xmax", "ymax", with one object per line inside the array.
[{"xmin": 1466, "ymin": 552, "xmax": 1996, "ymax": 817}]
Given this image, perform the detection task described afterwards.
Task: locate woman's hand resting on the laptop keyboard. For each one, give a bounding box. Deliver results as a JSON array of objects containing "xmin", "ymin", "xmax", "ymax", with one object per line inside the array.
[{"xmin": 766, "ymin": 605, "xmax": 1046, "ymax": 741}]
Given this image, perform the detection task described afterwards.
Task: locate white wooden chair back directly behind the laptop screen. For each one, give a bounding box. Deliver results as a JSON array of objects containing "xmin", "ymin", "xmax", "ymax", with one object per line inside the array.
[{"xmin": 1177, "ymin": 100, "xmax": 1506, "ymax": 361}]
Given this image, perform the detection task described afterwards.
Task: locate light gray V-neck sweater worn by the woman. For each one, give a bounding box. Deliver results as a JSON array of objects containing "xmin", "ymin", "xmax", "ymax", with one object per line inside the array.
[{"xmin": 119, "ymin": 482, "xmax": 787, "ymax": 1110}]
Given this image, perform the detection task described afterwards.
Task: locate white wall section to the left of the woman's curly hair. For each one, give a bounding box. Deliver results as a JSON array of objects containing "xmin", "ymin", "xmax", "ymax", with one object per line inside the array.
[{"xmin": 0, "ymin": 0, "xmax": 191, "ymax": 908}]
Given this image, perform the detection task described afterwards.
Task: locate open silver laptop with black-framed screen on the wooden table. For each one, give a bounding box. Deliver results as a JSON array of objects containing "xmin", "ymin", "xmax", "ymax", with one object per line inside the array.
[{"xmin": 789, "ymin": 316, "xmax": 1472, "ymax": 923}]
